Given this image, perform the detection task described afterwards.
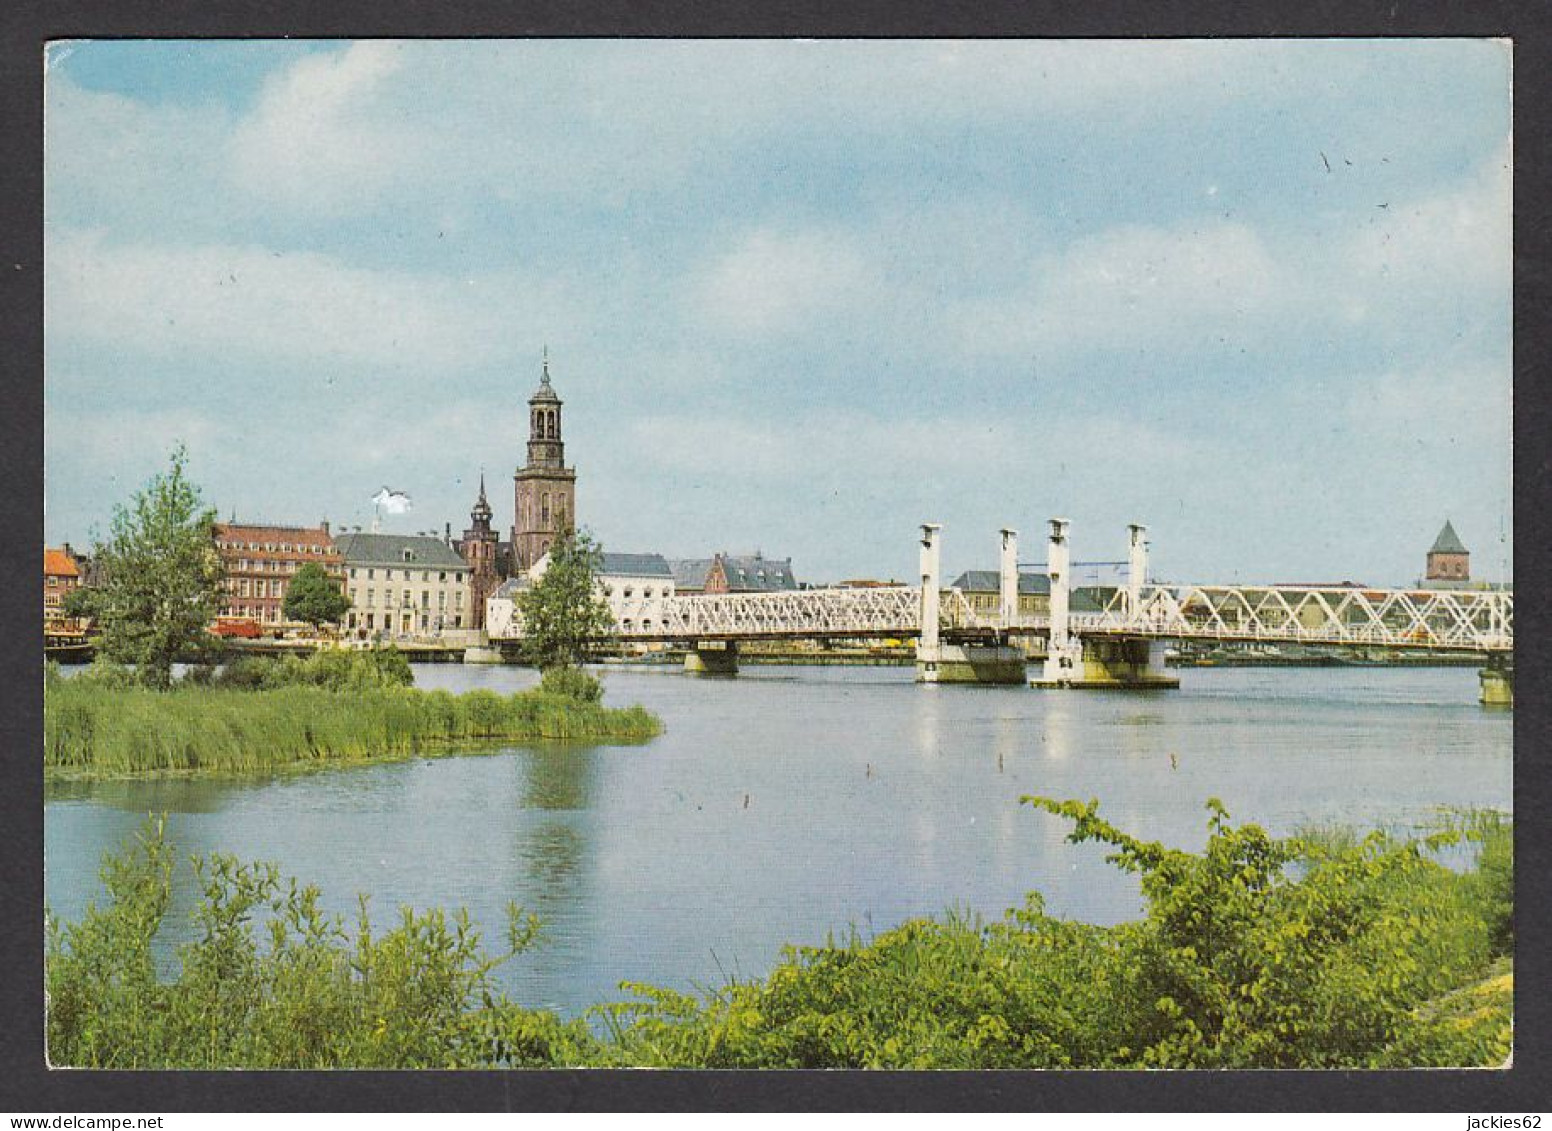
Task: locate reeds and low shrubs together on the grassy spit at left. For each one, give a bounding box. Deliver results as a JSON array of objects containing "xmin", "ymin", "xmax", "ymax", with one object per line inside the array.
[{"xmin": 43, "ymin": 649, "xmax": 661, "ymax": 777}]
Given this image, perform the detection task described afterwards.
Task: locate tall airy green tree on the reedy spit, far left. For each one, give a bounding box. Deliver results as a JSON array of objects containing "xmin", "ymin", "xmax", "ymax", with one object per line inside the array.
[{"xmin": 87, "ymin": 445, "xmax": 222, "ymax": 689}]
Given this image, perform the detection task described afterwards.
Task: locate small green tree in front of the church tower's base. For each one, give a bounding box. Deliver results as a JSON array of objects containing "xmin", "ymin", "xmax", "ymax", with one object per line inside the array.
[{"xmin": 517, "ymin": 531, "xmax": 615, "ymax": 670}]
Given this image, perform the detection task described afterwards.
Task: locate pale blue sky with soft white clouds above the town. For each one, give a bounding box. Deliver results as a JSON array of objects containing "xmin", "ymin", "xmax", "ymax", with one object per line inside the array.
[{"xmin": 45, "ymin": 39, "xmax": 1513, "ymax": 585}]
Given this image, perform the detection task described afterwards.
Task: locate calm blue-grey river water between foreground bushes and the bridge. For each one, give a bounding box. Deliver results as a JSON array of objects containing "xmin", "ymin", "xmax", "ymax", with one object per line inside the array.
[{"xmin": 45, "ymin": 666, "xmax": 1513, "ymax": 1013}]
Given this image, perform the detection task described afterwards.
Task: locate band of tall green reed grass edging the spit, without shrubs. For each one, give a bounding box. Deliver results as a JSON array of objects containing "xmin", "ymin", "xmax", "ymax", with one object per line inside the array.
[{"xmin": 43, "ymin": 680, "xmax": 661, "ymax": 776}]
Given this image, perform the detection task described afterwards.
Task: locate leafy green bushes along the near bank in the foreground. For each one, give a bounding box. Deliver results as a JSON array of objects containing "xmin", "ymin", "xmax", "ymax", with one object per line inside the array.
[{"xmin": 48, "ymin": 797, "xmax": 1513, "ymax": 1069}]
